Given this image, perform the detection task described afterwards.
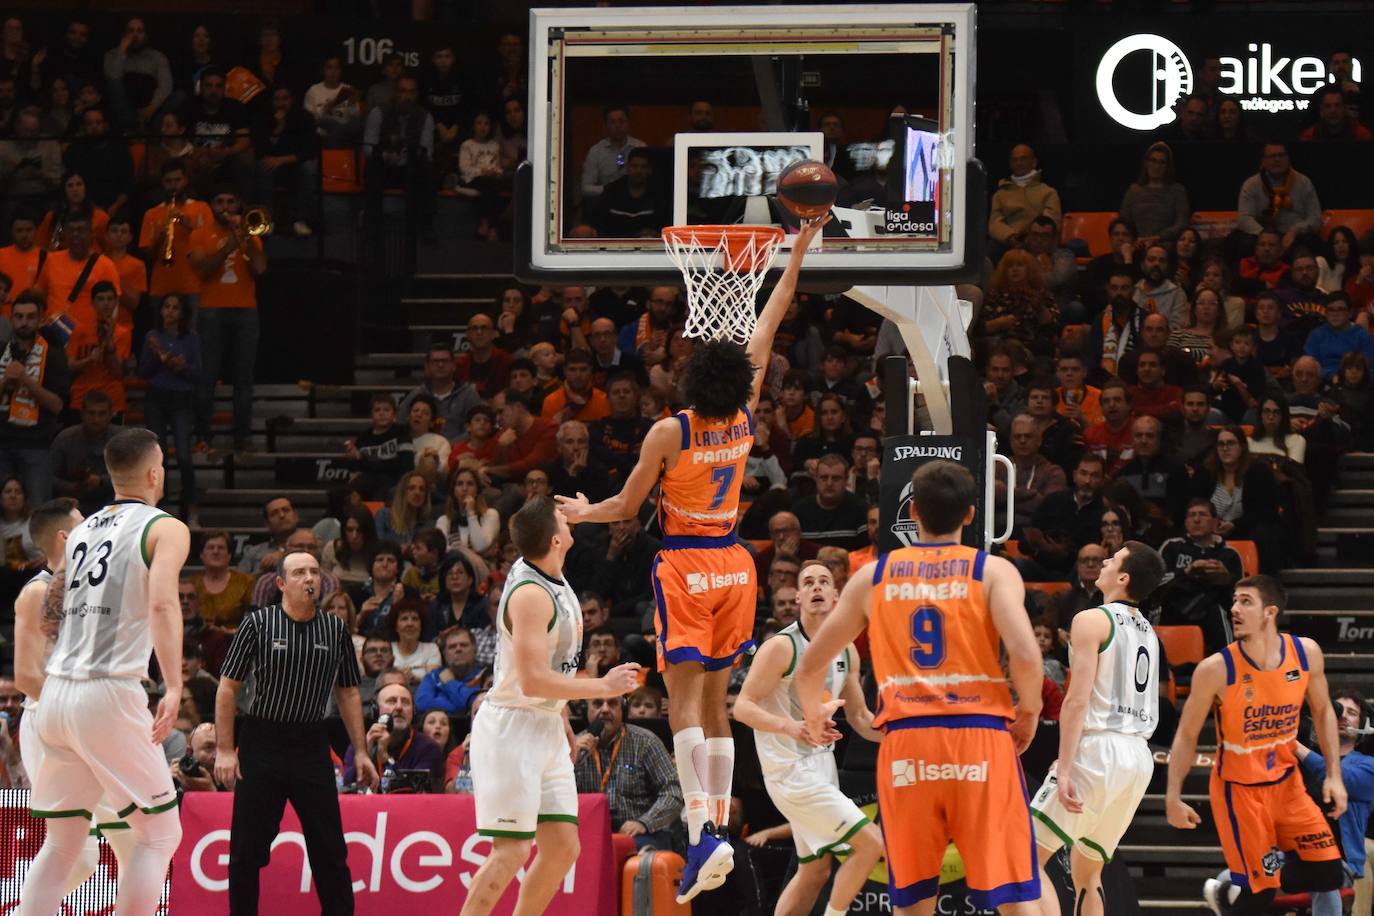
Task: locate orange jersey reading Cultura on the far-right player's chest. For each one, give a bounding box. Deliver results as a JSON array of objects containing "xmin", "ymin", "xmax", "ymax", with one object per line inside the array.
[{"xmin": 1215, "ymin": 633, "xmax": 1308, "ymax": 786}]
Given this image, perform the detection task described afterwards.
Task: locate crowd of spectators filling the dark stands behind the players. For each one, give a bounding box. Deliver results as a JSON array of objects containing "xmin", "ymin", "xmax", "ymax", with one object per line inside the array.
[{"xmin": 0, "ymin": 19, "xmax": 1374, "ymax": 867}]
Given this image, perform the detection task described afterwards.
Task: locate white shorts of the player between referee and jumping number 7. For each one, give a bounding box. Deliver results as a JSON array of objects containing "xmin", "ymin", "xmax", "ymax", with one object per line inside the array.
[{"xmin": 469, "ymin": 703, "xmax": 577, "ymax": 839}]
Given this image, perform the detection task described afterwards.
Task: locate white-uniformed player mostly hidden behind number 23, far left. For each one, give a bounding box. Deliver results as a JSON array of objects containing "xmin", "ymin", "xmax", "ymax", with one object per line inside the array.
[{"xmin": 14, "ymin": 497, "xmax": 133, "ymax": 898}]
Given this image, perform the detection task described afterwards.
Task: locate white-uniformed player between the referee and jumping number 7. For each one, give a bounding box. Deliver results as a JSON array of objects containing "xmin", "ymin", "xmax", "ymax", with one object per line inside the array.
[{"xmin": 462, "ymin": 497, "xmax": 639, "ymax": 916}]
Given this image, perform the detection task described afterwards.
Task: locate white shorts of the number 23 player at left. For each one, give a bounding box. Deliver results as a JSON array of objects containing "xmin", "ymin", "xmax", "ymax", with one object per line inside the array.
[{"xmin": 29, "ymin": 677, "xmax": 177, "ymax": 817}]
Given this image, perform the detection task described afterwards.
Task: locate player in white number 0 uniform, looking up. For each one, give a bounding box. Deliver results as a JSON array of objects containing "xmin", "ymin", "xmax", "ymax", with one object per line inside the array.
[{"xmin": 1031, "ymin": 541, "xmax": 1164, "ymax": 916}]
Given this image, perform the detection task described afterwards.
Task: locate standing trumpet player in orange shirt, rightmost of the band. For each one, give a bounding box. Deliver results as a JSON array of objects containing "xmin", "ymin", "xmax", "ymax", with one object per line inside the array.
[{"xmin": 190, "ymin": 187, "xmax": 267, "ymax": 452}]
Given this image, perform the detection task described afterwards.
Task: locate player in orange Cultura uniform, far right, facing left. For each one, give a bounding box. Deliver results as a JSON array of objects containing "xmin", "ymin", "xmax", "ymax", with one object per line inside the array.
[{"xmin": 1165, "ymin": 575, "xmax": 1347, "ymax": 916}]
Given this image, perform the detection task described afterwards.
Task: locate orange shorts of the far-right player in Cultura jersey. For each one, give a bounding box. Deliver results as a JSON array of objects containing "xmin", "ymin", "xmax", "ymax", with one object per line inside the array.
[{"xmin": 1209, "ymin": 766, "xmax": 1341, "ymax": 894}]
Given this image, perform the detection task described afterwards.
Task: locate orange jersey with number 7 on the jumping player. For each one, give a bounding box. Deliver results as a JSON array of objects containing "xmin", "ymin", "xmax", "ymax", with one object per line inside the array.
[{"xmin": 658, "ymin": 408, "xmax": 754, "ymax": 537}]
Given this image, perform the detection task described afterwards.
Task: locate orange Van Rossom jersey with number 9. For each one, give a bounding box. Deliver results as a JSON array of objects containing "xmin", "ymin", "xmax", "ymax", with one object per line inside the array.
[{"xmin": 868, "ymin": 544, "xmax": 1011, "ymax": 726}]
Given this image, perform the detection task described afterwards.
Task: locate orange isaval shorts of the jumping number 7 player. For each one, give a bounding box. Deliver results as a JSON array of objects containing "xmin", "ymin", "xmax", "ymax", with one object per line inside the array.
[{"xmin": 653, "ymin": 537, "xmax": 758, "ymax": 672}]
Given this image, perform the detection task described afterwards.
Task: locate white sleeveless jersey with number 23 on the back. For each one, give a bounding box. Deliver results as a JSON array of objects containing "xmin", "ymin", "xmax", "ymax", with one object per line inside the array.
[{"xmin": 47, "ymin": 500, "xmax": 170, "ymax": 680}]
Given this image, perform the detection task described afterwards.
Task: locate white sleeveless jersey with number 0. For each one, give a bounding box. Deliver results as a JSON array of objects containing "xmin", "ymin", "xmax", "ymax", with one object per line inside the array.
[{"xmin": 1070, "ymin": 602, "xmax": 1160, "ymax": 739}]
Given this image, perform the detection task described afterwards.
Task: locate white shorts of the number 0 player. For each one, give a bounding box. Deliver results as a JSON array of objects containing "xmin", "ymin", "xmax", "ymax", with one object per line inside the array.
[{"xmin": 1031, "ymin": 733, "xmax": 1154, "ymax": 862}]
